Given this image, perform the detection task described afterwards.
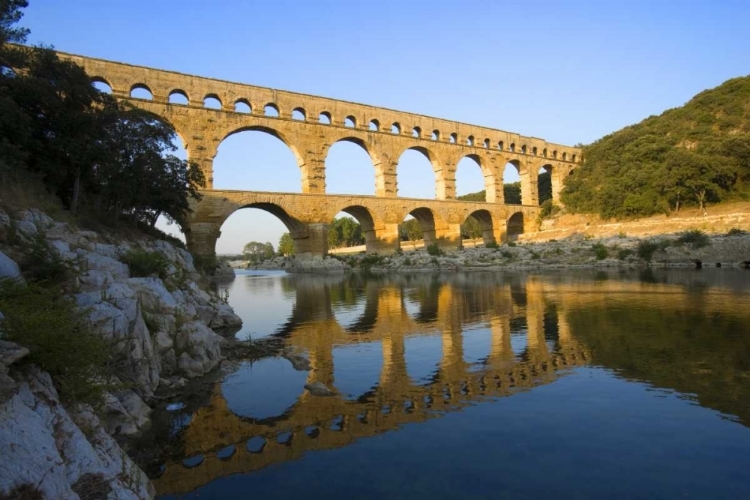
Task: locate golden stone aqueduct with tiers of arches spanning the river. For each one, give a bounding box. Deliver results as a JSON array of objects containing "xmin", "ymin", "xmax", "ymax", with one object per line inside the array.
[{"xmin": 59, "ymin": 53, "xmax": 581, "ymax": 256}]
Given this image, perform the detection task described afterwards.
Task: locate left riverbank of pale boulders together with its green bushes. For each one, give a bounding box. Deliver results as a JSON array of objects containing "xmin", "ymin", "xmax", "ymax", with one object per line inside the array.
[{"xmin": 0, "ymin": 209, "xmax": 241, "ymax": 499}]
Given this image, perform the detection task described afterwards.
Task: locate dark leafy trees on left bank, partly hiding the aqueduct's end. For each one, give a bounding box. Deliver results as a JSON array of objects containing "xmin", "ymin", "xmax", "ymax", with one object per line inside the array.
[{"xmin": 0, "ymin": 0, "xmax": 205, "ymax": 226}]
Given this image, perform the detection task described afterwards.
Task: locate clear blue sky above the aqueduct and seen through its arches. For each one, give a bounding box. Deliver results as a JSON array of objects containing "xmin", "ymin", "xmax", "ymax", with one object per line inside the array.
[{"xmin": 22, "ymin": 0, "xmax": 750, "ymax": 253}]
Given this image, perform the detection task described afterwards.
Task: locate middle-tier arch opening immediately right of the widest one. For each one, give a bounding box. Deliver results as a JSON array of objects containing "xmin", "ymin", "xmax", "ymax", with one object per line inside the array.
[{"xmin": 325, "ymin": 136, "xmax": 380, "ymax": 195}]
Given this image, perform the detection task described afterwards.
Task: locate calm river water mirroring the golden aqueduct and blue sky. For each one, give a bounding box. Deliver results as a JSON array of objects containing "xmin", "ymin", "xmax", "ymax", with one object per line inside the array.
[{"xmin": 148, "ymin": 269, "xmax": 750, "ymax": 499}]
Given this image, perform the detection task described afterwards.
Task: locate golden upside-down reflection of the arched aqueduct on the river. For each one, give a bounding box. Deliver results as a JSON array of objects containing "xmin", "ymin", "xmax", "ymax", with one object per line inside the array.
[{"xmin": 148, "ymin": 274, "xmax": 747, "ymax": 494}]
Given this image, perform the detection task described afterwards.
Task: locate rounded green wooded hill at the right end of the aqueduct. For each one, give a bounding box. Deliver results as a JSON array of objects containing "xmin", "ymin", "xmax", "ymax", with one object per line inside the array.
[{"xmin": 562, "ymin": 73, "xmax": 750, "ymax": 218}]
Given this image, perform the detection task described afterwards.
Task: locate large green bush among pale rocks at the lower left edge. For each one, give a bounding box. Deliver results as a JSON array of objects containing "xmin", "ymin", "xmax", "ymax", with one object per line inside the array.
[{"xmin": 0, "ymin": 280, "xmax": 114, "ymax": 404}]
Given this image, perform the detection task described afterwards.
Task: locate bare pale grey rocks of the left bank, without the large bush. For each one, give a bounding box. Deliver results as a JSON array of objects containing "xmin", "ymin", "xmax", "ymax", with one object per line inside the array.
[{"xmin": 0, "ymin": 210, "xmax": 241, "ymax": 499}]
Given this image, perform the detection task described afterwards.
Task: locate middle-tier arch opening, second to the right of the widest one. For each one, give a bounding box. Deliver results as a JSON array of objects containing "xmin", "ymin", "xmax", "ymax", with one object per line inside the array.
[{"xmin": 396, "ymin": 146, "xmax": 443, "ymax": 199}]
